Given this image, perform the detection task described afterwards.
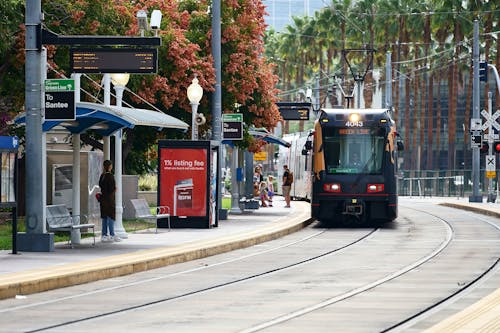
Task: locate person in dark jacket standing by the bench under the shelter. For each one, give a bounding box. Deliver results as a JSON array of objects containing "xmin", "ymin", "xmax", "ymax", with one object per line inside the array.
[{"xmin": 99, "ymin": 160, "xmax": 121, "ymax": 242}]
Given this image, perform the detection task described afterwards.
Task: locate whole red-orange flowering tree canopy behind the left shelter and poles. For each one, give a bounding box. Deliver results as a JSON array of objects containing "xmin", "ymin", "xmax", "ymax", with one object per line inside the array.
[{"xmin": 4, "ymin": 0, "xmax": 280, "ymax": 173}]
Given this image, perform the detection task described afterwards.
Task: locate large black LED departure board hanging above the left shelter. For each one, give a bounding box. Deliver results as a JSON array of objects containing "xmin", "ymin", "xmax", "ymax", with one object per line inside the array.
[{"xmin": 70, "ymin": 48, "xmax": 158, "ymax": 74}]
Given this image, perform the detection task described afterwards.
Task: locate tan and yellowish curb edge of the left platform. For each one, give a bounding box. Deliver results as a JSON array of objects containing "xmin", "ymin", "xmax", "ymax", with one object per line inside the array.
[{"xmin": 0, "ymin": 210, "xmax": 313, "ymax": 299}]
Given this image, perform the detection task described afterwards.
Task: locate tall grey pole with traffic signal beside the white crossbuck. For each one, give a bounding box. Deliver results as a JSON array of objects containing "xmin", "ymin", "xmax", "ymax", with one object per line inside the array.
[{"xmin": 469, "ymin": 20, "xmax": 483, "ymax": 202}]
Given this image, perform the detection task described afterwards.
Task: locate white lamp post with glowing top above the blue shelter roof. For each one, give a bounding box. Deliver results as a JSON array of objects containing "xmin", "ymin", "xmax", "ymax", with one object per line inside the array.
[{"xmin": 111, "ymin": 74, "xmax": 130, "ymax": 238}]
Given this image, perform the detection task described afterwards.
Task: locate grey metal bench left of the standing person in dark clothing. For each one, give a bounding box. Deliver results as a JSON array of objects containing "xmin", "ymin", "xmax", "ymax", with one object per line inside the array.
[{"xmin": 46, "ymin": 205, "xmax": 95, "ymax": 247}]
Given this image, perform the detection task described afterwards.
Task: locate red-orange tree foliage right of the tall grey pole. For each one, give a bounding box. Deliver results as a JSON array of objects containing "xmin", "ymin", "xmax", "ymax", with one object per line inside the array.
[{"xmin": 221, "ymin": 0, "xmax": 281, "ymax": 151}]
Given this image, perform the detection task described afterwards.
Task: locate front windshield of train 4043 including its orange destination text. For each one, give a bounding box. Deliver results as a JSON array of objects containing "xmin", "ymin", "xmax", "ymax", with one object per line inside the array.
[{"xmin": 323, "ymin": 128, "xmax": 386, "ymax": 174}]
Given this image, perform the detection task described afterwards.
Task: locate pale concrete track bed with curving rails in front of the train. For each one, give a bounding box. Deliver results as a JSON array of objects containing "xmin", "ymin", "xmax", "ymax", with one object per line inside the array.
[{"xmin": 0, "ymin": 201, "xmax": 500, "ymax": 332}]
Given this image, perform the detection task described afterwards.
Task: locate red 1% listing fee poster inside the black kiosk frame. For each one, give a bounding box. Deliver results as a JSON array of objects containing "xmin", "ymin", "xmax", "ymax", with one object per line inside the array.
[{"xmin": 158, "ymin": 148, "xmax": 208, "ymax": 216}]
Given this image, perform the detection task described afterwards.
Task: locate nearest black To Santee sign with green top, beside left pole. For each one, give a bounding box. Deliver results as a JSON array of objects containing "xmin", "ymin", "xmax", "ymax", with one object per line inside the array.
[{"xmin": 44, "ymin": 79, "xmax": 76, "ymax": 120}]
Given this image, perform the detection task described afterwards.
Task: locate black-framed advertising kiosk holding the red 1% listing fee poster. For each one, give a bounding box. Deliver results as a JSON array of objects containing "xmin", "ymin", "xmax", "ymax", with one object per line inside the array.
[{"xmin": 158, "ymin": 140, "xmax": 218, "ymax": 228}]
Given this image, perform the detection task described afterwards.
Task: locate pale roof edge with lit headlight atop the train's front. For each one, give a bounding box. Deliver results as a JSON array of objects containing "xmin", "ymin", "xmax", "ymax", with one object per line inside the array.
[{"xmin": 319, "ymin": 109, "xmax": 393, "ymax": 126}]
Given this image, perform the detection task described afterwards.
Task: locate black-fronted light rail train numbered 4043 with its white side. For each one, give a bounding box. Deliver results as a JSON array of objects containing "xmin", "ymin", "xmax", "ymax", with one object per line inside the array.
[{"xmin": 278, "ymin": 109, "xmax": 403, "ymax": 224}]
